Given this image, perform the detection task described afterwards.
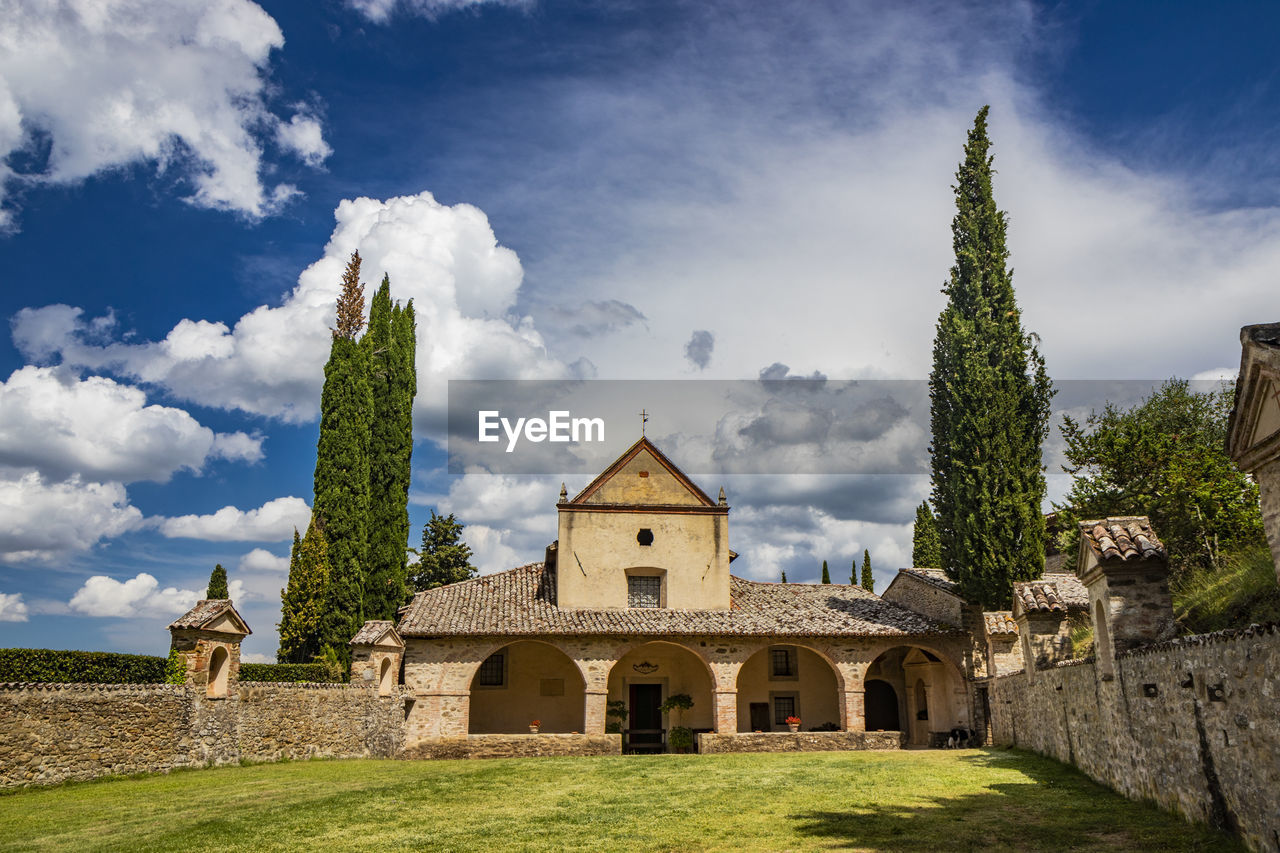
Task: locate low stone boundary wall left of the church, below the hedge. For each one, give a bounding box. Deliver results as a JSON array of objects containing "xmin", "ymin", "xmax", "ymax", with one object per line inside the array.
[{"xmin": 0, "ymin": 681, "xmax": 404, "ymax": 788}]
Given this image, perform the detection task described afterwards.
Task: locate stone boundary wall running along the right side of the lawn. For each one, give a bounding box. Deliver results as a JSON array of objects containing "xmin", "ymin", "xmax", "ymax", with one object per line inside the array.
[{"xmin": 991, "ymin": 625, "xmax": 1280, "ymax": 850}]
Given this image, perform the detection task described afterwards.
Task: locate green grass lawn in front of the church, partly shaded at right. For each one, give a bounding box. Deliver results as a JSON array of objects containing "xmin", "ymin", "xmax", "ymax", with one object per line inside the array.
[{"xmin": 0, "ymin": 749, "xmax": 1243, "ymax": 853}]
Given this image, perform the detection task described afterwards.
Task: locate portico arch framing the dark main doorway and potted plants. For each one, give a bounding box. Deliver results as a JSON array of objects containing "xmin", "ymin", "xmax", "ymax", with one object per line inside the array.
[{"xmin": 608, "ymin": 640, "xmax": 716, "ymax": 751}]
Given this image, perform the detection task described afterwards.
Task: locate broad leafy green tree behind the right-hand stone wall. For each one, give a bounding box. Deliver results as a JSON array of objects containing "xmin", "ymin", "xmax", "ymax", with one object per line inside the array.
[{"xmin": 1055, "ymin": 379, "xmax": 1263, "ymax": 575}]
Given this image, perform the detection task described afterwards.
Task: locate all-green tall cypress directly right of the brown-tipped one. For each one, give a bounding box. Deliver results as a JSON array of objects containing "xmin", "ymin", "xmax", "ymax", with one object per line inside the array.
[{"xmin": 360, "ymin": 275, "xmax": 417, "ymax": 619}]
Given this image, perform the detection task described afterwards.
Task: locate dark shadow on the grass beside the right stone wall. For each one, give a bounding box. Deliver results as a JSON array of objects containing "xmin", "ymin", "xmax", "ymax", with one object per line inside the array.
[{"xmin": 788, "ymin": 749, "xmax": 1245, "ymax": 853}]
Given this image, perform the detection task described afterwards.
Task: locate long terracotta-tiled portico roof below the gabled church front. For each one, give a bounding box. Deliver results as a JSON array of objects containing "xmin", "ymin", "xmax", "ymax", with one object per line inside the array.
[{"xmin": 399, "ymin": 562, "xmax": 956, "ymax": 637}]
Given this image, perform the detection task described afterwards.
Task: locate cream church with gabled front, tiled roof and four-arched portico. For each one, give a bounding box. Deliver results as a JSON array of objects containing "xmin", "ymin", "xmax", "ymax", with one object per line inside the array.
[{"xmin": 394, "ymin": 438, "xmax": 982, "ymax": 751}]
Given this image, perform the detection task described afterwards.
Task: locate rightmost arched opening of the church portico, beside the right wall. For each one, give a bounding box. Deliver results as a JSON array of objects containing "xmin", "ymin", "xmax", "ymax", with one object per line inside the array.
[{"xmin": 863, "ymin": 644, "xmax": 970, "ymax": 747}]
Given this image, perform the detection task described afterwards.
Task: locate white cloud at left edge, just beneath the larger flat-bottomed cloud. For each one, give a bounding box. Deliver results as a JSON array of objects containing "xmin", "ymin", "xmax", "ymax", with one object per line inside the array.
[{"xmin": 0, "ymin": 471, "xmax": 142, "ymax": 561}]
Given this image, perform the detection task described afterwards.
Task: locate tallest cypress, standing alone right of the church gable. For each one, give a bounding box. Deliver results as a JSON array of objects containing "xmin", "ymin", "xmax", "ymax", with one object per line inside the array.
[{"xmin": 929, "ymin": 106, "xmax": 1053, "ymax": 610}]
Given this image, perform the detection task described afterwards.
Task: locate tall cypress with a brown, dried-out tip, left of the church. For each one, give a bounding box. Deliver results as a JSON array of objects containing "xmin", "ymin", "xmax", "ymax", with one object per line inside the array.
[{"xmin": 312, "ymin": 252, "xmax": 372, "ymax": 660}]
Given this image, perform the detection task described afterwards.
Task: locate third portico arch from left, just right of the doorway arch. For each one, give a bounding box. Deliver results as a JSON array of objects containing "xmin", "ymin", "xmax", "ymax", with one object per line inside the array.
[{"xmin": 736, "ymin": 640, "xmax": 845, "ymax": 731}]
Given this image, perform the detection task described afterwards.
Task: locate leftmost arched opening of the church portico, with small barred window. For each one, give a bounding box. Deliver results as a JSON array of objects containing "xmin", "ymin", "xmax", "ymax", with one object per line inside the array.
[{"xmin": 466, "ymin": 638, "xmax": 586, "ymax": 734}]
